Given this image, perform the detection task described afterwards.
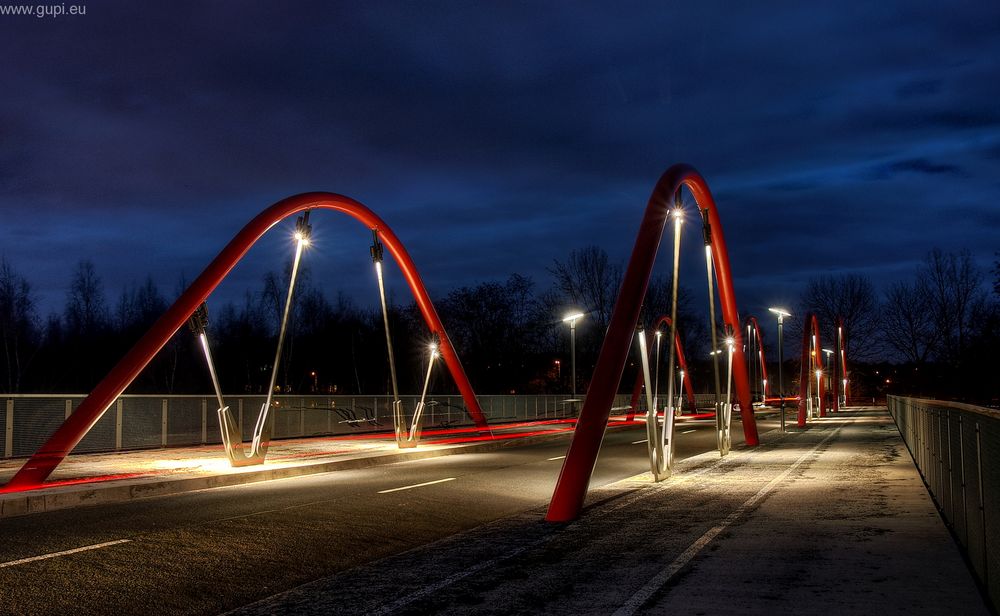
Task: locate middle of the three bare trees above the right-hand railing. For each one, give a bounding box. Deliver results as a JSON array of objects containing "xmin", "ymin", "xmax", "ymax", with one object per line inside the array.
[{"xmin": 881, "ymin": 282, "xmax": 938, "ymax": 364}]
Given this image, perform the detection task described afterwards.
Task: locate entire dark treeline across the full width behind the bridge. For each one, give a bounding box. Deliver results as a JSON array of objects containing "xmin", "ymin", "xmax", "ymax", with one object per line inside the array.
[{"xmin": 0, "ymin": 246, "xmax": 1000, "ymax": 403}]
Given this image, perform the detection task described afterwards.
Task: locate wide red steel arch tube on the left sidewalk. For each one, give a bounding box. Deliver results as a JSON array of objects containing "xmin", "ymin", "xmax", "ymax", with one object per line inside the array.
[{"xmin": 2, "ymin": 192, "xmax": 489, "ymax": 492}]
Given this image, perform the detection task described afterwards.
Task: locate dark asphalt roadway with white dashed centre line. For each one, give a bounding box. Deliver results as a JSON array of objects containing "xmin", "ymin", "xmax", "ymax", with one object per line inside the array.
[{"xmin": 0, "ymin": 420, "xmax": 742, "ymax": 615}]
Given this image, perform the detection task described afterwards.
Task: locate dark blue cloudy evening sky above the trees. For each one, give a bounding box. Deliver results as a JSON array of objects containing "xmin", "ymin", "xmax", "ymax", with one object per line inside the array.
[{"xmin": 0, "ymin": 0, "xmax": 1000, "ymax": 322}]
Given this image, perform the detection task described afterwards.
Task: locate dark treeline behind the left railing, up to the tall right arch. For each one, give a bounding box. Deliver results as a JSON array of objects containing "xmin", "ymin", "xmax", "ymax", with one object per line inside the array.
[{"xmin": 0, "ymin": 247, "xmax": 698, "ymax": 394}]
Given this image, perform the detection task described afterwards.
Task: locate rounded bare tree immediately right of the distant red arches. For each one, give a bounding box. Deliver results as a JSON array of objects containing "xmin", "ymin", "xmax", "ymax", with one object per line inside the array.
[{"xmin": 799, "ymin": 274, "xmax": 881, "ymax": 362}]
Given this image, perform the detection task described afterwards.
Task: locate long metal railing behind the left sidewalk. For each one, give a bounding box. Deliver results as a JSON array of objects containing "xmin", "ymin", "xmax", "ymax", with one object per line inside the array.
[{"xmin": 0, "ymin": 394, "xmax": 628, "ymax": 458}]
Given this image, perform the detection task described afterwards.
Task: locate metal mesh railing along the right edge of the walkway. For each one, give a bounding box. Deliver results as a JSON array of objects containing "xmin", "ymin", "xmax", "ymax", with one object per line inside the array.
[{"xmin": 887, "ymin": 396, "xmax": 1000, "ymax": 606}]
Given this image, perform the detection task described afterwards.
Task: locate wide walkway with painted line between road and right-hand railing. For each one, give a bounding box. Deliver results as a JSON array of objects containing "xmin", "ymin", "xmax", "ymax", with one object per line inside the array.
[{"xmin": 233, "ymin": 409, "xmax": 990, "ymax": 616}]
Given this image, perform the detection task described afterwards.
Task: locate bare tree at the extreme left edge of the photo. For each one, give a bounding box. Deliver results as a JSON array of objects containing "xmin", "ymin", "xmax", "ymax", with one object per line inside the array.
[{"xmin": 0, "ymin": 258, "xmax": 38, "ymax": 393}]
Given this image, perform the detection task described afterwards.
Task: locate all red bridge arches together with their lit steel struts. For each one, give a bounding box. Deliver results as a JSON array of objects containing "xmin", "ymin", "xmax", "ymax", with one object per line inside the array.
[{"xmin": 0, "ymin": 165, "xmax": 848, "ymax": 521}]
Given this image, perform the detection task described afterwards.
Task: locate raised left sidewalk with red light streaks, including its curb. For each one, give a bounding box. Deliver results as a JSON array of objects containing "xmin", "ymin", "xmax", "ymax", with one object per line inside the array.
[{"xmin": 0, "ymin": 417, "xmax": 641, "ymax": 519}]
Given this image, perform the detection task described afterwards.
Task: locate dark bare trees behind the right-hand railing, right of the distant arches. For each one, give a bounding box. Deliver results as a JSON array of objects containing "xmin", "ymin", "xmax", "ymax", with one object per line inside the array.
[{"xmin": 796, "ymin": 249, "xmax": 1000, "ymax": 406}]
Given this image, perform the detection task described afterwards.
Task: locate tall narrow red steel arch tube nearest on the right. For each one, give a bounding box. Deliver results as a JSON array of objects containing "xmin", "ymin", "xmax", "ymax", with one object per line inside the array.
[{"xmin": 545, "ymin": 165, "xmax": 759, "ymax": 522}]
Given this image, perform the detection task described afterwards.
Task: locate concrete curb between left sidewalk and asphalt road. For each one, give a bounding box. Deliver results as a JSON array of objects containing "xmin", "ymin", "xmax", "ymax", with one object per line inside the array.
[{"xmin": 0, "ymin": 422, "xmax": 644, "ymax": 520}]
